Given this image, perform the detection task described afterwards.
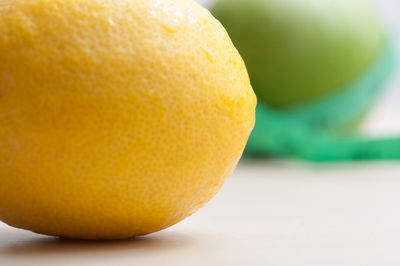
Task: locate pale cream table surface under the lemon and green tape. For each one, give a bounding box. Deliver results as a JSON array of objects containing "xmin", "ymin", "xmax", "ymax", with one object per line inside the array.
[{"xmin": 0, "ymin": 160, "xmax": 400, "ymax": 266}]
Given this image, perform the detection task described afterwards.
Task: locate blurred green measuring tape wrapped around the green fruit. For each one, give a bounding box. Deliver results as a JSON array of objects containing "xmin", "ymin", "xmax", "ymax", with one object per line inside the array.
[{"xmin": 245, "ymin": 42, "xmax": 400, "ymax": 161}]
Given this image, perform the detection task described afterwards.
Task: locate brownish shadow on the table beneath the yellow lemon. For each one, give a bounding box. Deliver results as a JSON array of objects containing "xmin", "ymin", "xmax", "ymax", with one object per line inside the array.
[{"xmin": 0, "ymin": 228, "xmax": 195, "ymax": 264}]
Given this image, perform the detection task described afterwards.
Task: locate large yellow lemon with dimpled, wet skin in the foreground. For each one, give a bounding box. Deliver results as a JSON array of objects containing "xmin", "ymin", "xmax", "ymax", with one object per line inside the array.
[{"xmin": 0, "ymin": 0, "xmax": 256, "ymax": 239}]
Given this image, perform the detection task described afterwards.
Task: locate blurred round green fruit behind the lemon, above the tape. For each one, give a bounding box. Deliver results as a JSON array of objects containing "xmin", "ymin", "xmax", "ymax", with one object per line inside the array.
[{"xmin": 212, "ymin": 0, "xmax": 384, "ymax": 107}]
